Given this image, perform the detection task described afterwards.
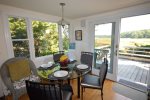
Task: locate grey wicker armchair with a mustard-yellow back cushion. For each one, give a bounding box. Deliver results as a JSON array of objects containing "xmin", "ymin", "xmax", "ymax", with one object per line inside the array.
[{"xmin": 0, "ymin": 57, "xmax": 39, "ymax": 100}]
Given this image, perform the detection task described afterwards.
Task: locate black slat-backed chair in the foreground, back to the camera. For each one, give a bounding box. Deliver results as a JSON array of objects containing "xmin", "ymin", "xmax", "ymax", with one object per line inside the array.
[{"xmin": 26, "ymin": 80, "xmax": 72, "ymax": 100}]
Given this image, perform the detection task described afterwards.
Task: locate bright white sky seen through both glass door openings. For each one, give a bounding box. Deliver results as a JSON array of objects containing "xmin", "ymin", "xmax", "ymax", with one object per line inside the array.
[{"xmin": 95, "ymin": 14, "xmax": 150, "ymax": 35}]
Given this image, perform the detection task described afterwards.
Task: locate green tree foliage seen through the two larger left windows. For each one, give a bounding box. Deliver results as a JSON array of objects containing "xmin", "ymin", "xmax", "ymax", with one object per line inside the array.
[{"xmin": 8, "ymin": 17, "xmax": 59, "ymax": 57}]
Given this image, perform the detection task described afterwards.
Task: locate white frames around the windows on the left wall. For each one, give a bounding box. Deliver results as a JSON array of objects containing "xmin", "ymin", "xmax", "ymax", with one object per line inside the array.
[{"xmin": 4, "ymin": 15, "xmax": 70, "ymax": 59}]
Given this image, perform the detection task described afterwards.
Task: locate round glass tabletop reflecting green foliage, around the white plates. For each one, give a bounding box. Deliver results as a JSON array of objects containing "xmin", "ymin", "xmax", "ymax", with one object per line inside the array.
[{"xmin": 38, "ymin": 63, "xmax": 91, "ymax": 80}]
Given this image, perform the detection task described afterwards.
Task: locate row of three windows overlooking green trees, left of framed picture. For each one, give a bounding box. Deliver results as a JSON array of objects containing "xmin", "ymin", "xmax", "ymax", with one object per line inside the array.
[{"xmin": 8, "ymin": 16, "xmax": 69, "ymax": 58}]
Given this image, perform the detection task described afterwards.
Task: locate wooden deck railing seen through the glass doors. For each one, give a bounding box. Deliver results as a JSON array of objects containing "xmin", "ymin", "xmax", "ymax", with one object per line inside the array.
[{"xmin": 94, "ymin": 45, "xmax": 150, "ymax": 62}]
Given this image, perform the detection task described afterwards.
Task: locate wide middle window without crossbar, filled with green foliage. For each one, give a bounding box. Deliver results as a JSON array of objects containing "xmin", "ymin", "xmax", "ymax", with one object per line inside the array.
[{"xmin": 32, "ymin": 21, "xmax": 59, "ymax": 57}]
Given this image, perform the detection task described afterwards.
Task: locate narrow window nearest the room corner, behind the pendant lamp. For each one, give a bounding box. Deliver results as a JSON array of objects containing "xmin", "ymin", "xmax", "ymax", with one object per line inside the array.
[{"xmin": 61, "ymin": 25, "xmax": 69, "ymax": 51}]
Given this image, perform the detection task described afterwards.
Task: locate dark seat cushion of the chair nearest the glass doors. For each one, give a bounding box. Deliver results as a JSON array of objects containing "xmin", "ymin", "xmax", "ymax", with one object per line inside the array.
[{"xmin": 81, "ymin": 75, "xmax": 101, "ymax": 88}]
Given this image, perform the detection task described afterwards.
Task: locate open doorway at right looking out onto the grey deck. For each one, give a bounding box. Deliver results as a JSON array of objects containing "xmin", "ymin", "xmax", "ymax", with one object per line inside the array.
[{"xmin": 118, "ymin": 14, "xmax": 150, "ymax": 86}]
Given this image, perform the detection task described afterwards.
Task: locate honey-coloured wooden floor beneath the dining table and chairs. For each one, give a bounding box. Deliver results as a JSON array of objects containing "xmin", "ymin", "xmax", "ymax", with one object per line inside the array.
[{"xmin": 6, "ymin": 80, "xmax": 131, "ymax": 100}]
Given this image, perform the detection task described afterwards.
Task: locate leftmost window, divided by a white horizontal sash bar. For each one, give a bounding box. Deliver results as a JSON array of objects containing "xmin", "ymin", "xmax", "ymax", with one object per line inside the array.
[{"xmin": 8, "ymin": 17, "xmax": 30, "ymax": 58}]
